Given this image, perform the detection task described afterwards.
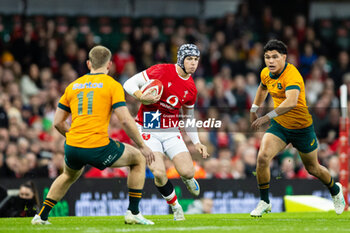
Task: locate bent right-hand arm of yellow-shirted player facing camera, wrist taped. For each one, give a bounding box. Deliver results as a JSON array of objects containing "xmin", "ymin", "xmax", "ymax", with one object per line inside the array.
[{"xmin": 252, "ymin": 89, "xmax": 300, "ymax": 129}]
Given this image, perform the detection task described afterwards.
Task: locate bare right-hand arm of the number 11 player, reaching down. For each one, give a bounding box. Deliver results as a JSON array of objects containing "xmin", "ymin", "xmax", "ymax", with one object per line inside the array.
[{"xmin": 114, "ymin": 106, "xmax": 155, "ymax": 165}]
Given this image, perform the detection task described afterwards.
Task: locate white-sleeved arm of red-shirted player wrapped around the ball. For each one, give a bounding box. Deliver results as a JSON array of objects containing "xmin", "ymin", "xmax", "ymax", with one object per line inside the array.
[{"xmin": 123, "ymin": 70, "xmax": 160, "ymax": 105}]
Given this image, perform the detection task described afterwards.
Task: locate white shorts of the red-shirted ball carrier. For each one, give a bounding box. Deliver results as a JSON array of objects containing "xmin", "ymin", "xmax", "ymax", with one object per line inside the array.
[{"xmin": 137, "ymin": 124, "xmax": 188, "ymax": 160}]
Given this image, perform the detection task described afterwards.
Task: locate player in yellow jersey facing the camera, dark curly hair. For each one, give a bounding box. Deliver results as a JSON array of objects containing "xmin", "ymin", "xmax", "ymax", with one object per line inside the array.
[{"xmin": 250, "ymin": 40, "xmax": 345, "ymax": 217}]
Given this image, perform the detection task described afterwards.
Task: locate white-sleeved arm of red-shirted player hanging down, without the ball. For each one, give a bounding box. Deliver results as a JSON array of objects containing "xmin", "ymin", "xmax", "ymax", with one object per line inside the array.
[{"xmin": 182, "ymin": 107, "xmax": 209, "ymax": 158}]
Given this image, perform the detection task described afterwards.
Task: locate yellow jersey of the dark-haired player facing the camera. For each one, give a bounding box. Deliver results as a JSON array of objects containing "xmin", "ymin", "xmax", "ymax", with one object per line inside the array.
[{"xmin": 260, "ymin": 63, "xmax": 312, "ymax": 129}]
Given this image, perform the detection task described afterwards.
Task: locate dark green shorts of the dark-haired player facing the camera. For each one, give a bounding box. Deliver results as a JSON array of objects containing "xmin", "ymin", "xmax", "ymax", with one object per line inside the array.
[{"xmin": 266, "ymin": 119, "xmax": 318, "ymax": 153}]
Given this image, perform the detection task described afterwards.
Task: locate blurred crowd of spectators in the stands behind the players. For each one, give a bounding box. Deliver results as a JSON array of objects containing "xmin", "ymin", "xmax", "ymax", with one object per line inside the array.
[{"xmin": 0, "ymin": 4, "xmax": 350, "ymax": 179}]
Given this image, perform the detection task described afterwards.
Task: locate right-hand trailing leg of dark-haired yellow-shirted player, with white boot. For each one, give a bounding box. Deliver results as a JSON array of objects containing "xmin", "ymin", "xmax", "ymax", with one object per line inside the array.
[{"xmin": 299, "ymin": 149, "xmax": 345, "ymax": 214}]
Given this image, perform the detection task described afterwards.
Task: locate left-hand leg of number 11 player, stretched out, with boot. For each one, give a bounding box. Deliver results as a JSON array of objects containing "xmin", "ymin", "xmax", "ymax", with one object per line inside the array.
[{"xmin": 32, "ymin": 164, "xmax": 84, "ymax": 225}]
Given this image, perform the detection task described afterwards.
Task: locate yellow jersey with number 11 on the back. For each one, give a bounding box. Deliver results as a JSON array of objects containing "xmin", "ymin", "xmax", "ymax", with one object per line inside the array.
[{"xmin": 58, "ymin": 73, "xmax": 126, "ymax": 148}]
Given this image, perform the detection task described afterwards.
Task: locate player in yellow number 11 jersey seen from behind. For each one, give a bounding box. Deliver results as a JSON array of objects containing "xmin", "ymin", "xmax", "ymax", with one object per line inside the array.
[{"xmin": 32, "ymin": 46, "xmax": 154, "ymax": 225}]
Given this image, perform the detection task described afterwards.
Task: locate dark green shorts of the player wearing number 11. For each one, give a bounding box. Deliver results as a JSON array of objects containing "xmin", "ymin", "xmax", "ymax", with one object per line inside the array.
[{"xmin": 64, "ymin": 139, "xmax": 125, "ymax": 170}]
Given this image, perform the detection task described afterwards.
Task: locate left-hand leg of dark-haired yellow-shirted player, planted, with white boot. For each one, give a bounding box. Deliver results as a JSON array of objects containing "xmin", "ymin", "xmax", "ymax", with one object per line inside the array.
[{"xmin": 250, "ymin": 132, "xmax": 287, "ymax": 217}]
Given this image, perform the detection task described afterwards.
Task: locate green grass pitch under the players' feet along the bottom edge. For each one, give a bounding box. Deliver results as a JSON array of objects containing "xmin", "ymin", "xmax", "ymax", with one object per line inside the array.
[{"xmin": 0, "ymin": 212, "xmax": 350, "ymax": 233}]
